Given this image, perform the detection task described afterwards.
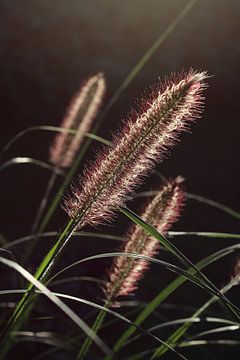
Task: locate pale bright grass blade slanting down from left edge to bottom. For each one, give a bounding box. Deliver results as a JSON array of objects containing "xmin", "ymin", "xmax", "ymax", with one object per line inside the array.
[{"xmin": 0, "ymin": 257, "xmax": 111, "ymax": 359}]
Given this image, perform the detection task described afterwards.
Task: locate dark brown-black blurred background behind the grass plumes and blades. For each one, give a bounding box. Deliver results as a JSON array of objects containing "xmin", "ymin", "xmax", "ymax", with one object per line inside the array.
[{"xmin": 0, "ymin": 0, "xmax": 240, "ymax": 358}]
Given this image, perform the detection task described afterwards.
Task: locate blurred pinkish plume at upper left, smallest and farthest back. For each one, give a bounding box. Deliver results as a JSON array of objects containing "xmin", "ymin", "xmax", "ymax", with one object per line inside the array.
[{"xmin": 49, "ymin": 73, "xmax": 106, "ymax": 168}]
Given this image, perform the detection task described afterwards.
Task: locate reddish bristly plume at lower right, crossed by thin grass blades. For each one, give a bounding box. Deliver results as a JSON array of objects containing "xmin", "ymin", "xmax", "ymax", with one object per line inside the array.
[{"xmin": 104, "ymin": 177, "xmax": 185, "ymax": 304}]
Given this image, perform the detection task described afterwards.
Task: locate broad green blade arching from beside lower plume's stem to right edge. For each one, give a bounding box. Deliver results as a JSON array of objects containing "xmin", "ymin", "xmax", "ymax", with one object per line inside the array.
[{"xmin": 108, "ymin": 244, "xmax": 240, "ymax": 360}]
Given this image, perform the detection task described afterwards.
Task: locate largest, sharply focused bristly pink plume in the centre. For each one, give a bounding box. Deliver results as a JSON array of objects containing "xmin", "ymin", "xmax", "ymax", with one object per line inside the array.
[{"xmin": 65, "ymin": 69, "xmax": 207, "ymax": 228}]
